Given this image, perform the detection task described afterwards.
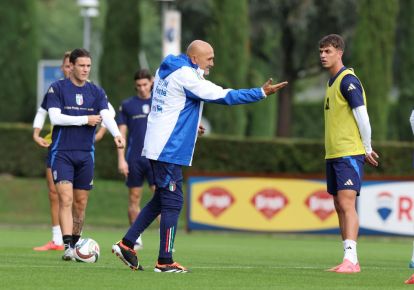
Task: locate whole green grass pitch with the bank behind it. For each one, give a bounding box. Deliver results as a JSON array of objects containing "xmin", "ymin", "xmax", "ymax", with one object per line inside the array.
[{"xmin": 0, "ymin": 177, "xmax": 414, "ymax": 290}]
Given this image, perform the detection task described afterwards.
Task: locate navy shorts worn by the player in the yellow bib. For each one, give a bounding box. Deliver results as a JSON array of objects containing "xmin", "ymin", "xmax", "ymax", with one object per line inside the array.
[{"xmin": 326, "ymin": 155, "xmax": 365, "ymax": 196}]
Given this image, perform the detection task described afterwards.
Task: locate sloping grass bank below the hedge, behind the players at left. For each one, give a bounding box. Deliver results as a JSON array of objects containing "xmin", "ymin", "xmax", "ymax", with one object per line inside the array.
[{"xmin": 0, "ymin": 175, "xmax": 170, "ymax": 228}]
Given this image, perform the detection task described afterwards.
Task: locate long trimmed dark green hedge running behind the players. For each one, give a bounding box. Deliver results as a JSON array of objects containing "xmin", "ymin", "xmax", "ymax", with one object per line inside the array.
[{"xmin": 0, "ymin": 124, "xmax": 414, "ymax": 179}]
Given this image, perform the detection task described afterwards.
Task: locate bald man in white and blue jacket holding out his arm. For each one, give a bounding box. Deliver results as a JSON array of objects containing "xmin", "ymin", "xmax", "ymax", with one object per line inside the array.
[{"xmin": 112, "ymin": 40, "xmax": 287, "ymax": 273}]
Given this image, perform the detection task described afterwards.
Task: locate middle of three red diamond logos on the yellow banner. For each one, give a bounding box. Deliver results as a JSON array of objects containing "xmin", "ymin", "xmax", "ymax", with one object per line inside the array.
[{"xmin": 251, "ymin": 188, "xmax": 289, "ymax": 220}]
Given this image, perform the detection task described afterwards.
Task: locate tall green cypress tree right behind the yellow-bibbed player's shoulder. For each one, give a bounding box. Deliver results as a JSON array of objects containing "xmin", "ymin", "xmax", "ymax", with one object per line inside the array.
[{"xmin": 352, "ymin": 0, "xmax": 398, "ymax": 140}]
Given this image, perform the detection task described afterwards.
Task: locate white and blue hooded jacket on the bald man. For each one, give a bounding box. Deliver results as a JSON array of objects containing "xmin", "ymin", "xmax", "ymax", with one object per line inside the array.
[{"xmin": 142, "ymin": 54, "xmax": 266, "ymax": 166}]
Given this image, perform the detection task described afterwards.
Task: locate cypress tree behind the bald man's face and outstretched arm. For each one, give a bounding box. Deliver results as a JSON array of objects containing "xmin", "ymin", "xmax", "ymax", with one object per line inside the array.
[{"xmin": 206, "ymin": 0, "xmax": 249, "ymax": 136}]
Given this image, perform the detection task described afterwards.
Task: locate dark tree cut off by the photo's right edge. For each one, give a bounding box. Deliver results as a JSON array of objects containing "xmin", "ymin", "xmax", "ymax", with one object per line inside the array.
[{"xmin": 395, "ymin": 0, "xmax": 414, "ymax": 140}]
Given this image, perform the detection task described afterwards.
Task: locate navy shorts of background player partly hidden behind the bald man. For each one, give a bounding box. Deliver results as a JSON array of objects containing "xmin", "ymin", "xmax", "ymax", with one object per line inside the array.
[{"xmin": 125, "ymin": 156, "xmax": 154, "ymax": 188}]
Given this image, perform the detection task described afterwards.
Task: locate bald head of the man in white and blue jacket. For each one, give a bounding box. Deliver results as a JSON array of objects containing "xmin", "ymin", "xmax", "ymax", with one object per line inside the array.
[{"xmin": 187, "ymin": 40, "xmax": 214, "ymax": 75}]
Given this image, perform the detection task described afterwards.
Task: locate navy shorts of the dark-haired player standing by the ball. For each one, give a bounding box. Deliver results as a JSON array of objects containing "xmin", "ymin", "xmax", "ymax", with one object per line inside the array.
[{"xmin": 51, "ymin": 151, "xmax": 94, "ymax": 190}]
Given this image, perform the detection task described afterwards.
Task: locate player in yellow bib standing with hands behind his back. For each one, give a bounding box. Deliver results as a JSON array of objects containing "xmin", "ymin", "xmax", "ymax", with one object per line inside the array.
[{"xmin": 319, "ymin": 34, "xmax": 378, "ymax": 273}]
